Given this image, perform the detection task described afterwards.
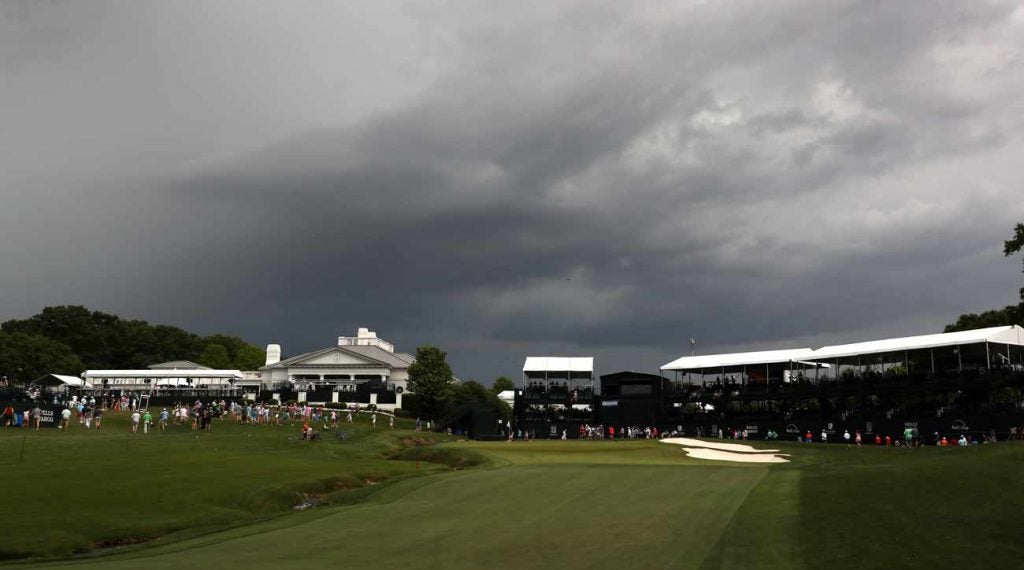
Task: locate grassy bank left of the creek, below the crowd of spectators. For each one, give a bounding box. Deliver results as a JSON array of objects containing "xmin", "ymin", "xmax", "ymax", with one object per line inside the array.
[{"xmin": 0, "ymin": 413, "xmax": 458, "ymax": 559}]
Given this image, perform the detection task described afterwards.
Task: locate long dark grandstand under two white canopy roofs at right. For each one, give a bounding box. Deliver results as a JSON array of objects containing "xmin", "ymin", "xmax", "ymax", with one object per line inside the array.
[{"xmin": 662, "ymin": 325, "xmax": 1024, "ymax": 439}]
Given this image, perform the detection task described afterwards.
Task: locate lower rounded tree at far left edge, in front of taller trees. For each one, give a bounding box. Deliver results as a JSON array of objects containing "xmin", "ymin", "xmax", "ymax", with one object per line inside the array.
[{"xmin": 0, "ymin": 333, "xmax": 82, "ymax": 384}]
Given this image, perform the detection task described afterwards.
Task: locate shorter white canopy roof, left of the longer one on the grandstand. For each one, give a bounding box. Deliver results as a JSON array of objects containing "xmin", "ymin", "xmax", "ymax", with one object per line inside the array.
[{"xmin": 662, "ymin": 348, "xmax": 827, "ymax": 382}]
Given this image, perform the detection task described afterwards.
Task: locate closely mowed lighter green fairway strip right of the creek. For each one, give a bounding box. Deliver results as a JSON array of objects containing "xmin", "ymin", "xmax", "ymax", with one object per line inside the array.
[{"xmin": 32, "ymin": 465, "xmax": 765, "ymax": 569}]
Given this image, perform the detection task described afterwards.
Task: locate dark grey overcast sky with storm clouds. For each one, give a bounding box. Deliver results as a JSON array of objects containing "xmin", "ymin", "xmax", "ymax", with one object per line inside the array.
[{"xmin": 0, "ymin": 0, "xmax": 1024, "ymax": 383}]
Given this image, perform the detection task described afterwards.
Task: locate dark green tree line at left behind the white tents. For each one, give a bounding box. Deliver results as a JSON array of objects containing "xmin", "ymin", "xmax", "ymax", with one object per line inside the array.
[{"xmin": 0, "ymin": 305, "xmax": 266, "ymax": 384}]
